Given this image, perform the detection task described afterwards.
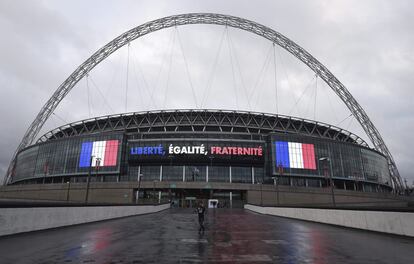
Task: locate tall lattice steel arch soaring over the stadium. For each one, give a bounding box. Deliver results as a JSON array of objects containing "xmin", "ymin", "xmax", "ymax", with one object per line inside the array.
[{"xmin": 5, "ymin": 13, "xmax": 404, "ymax": 189}]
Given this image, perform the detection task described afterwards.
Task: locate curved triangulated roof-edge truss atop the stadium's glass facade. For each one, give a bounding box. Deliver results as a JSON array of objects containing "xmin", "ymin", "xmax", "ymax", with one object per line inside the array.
[{"xmin": 37, "ymin": 109, "xmax": 368, "ymax": 147}]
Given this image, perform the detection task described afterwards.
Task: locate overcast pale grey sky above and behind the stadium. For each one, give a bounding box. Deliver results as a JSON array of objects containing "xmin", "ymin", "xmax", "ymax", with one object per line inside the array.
[{"xmin": 0, "ymin": 0, "xmax": 414, "ymax": 183}]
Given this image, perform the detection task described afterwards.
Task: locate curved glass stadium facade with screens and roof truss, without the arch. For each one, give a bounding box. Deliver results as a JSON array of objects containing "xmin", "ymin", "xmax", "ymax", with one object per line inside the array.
[{"xmin": 10, "ymin": 110, "xmax": 392, "ymax": 192}]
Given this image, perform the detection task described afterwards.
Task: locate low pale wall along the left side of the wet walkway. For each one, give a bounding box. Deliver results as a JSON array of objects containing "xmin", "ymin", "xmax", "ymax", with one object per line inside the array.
[{"xmin": 0, "ymin": 204, "xmax": 170, "ymax": 236}]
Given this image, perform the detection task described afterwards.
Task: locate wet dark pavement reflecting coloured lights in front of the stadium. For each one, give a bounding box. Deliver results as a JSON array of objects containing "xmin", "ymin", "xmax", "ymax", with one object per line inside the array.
[{"xmin": 0, "ymin": 209, "xmax": 414, "ymax": 264}]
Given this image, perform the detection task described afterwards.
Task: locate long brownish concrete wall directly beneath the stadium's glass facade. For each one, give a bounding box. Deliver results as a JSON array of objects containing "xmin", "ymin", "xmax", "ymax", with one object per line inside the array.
[{"xmin": 0, "ymin": 181, "xmax": 408, "ymax": 207}]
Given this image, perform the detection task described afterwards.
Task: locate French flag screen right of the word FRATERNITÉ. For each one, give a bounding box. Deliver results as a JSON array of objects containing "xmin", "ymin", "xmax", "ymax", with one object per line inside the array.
[{"xmin": 275, "ymin": 141, "xmax": 316, "ymax": 170}]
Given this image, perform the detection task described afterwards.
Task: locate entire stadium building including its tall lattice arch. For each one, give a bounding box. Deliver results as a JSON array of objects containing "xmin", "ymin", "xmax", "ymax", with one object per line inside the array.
[{"xmin": 0, "ymin": 13, "xmax": 404, "ymax": 207}]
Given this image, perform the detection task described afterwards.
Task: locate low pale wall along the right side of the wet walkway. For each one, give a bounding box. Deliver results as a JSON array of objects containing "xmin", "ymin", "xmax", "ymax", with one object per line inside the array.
[{"xmin": 245, "ymin": 204, "xmax": 414, "ymax": 237}]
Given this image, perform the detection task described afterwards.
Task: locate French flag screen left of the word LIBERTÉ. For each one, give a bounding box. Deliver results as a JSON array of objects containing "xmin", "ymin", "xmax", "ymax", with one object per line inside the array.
[{"xmin": 79, "ymin": 140, "xmax": 118, "ymax": 168}]
